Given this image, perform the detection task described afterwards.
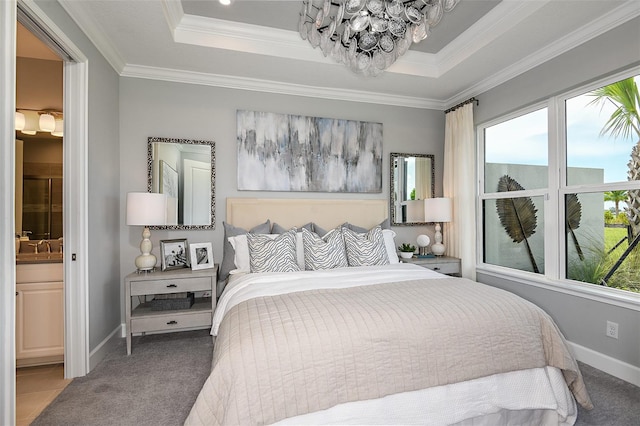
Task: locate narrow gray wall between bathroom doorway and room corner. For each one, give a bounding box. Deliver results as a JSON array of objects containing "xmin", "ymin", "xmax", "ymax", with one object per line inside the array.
[{"xmin": 37, "ymin": 0, "xmax": 121, "ymax": 350}]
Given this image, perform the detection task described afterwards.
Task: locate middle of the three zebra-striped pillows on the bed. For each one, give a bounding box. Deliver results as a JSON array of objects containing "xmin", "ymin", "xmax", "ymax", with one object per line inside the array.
[{"xmin": 302, "ymin": 228, "xmax": 349, "ymax": 271}]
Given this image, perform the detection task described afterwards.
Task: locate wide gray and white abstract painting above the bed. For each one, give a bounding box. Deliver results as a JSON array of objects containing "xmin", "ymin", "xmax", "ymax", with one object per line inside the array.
[{"xmin": 237, "ymin": 110, "xmax": 382, "ymax": 193}]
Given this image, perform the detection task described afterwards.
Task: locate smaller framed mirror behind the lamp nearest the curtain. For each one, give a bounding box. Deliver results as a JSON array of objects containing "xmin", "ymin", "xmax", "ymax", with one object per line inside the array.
[{"xmin": 389, "ymin": 152, "xmax": 435, "ymax": 226}]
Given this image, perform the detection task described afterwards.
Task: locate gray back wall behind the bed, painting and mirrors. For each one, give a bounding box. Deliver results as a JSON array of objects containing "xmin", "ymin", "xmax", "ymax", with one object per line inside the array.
[{"xmin": 120, "ymin": 78, "xmax": 444, "ymax": 312}]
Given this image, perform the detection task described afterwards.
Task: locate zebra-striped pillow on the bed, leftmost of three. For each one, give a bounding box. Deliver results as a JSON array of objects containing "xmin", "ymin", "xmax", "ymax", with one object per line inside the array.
[{"xmin": 247, "ymin": 228, "xmax": 300, "ymax": 272}]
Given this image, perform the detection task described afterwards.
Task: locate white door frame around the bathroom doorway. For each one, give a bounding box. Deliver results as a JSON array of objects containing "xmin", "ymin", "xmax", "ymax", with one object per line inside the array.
[{"xmin": 0, "ymin": 0, "xmax": 90, "ymax": 424}]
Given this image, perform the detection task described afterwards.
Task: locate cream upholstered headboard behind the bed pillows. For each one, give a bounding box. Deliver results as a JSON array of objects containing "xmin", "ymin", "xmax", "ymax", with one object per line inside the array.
[{"xmin": 226, "ymin": 198, "xmax": 389, "ymax": 229}]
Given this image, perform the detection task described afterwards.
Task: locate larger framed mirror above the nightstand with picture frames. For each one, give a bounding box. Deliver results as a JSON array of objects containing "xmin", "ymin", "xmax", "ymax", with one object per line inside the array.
[{"xmin": 147, "ymin": 137, "xmax": 216, "ymax": 229}]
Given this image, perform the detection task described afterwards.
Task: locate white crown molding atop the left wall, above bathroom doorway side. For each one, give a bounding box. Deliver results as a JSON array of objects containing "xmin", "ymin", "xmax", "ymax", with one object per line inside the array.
[{"xmin": 58, "ymin": 0, "xmax": 126, "ymax": 74}]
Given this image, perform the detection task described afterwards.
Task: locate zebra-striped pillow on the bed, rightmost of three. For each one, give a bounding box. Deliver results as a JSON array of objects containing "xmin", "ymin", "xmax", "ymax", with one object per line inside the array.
[{"xmin": 342, "ymin": 226, "xmax": 389, "ymax": 266}]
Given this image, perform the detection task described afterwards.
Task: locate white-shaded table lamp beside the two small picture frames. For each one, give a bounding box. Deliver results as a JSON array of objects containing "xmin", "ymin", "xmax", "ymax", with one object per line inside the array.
[{"xmin": 127, "ymin": 192, "xmax": 167, "ymax": 272}]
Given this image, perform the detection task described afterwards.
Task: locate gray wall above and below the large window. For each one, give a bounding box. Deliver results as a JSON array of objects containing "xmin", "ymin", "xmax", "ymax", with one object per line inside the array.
[{"xmin": 475, "ymin": 19, "xmax": 640, "ymax": 367}]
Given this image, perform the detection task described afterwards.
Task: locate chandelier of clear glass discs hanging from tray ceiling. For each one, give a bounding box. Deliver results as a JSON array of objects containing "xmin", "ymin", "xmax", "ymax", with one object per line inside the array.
[{"xmin": 298, "ymin": 0, "xmax": 459, "ymax": 76}]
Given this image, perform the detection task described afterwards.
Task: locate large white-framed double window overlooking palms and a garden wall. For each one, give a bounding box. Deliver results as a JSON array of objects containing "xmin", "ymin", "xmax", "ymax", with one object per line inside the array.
[{"xmin": 478, "ymin": 70, "xmax": 640, "ymax": 293}]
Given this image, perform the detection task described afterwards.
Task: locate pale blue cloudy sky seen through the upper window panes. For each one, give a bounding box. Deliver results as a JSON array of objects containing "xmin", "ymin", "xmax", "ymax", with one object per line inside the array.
[{"xmin": 485, "ymin": 76, "xmax": 640, "ymax": 182}]
